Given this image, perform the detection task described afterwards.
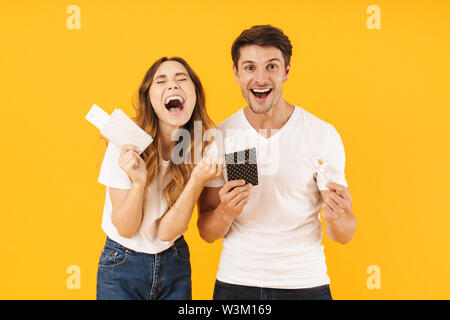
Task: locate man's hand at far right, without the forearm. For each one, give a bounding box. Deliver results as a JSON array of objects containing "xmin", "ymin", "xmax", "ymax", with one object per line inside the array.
[{"xmin": 322, "ymin": 182, "xmax": 353, "ymax": 224}]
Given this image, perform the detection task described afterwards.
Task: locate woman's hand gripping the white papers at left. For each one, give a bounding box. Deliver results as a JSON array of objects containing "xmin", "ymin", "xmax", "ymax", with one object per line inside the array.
[{"xmin": 119, "ymin": 144, "xmax": 147, "ymax": 186}]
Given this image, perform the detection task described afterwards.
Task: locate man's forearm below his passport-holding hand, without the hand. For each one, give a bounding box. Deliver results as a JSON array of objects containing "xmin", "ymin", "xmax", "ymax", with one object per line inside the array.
[{"xmin": 197, "ymin": 208, "xmax": 233, "ymax": 243}]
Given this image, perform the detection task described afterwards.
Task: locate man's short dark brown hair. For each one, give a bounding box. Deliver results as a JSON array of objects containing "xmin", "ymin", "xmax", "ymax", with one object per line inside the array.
[{"xmin": 231, "ymin": 25, "xmax": 292, "ymax": 69}]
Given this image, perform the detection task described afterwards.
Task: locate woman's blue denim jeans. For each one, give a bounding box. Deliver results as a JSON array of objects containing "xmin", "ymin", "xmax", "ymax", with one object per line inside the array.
[{"xmin": 97, "ymin": 236, "xmax": 192, "ymax": 300}]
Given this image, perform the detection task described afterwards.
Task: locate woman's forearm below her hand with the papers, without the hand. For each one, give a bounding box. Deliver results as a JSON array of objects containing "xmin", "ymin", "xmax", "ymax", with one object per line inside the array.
[{"xmin": 111, "ymin": 184, "xmax": 144, "ymax": 238}]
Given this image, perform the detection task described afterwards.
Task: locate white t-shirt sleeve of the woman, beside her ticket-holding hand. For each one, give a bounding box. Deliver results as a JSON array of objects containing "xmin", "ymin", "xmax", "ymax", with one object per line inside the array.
[{"xmin": 98, "ymin": 142, "xmax": 131, "ymax": 189}]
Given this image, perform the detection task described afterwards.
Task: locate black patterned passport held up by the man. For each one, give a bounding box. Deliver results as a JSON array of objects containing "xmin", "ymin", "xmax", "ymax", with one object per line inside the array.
[{"xmin": 225, "ymin": 148, "xmax": 258, "ymax": 186}]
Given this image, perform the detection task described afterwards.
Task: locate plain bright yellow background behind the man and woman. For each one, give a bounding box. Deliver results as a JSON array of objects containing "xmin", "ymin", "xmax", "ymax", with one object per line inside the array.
[{"xmin": 0, "ymin": 0, "xmax": 450, "ymax": 299}]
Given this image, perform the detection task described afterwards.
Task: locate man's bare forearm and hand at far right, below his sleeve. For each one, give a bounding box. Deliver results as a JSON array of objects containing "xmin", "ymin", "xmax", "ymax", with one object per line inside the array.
[{"xmin": 320, "ymin": 182, "xmax": 356, "ymax": 244}]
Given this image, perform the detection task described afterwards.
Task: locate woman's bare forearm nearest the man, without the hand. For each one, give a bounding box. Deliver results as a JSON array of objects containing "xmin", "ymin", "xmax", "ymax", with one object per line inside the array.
[{"xmin": 158, "ymin": 177, "xmax": 205, "ymax": 241}]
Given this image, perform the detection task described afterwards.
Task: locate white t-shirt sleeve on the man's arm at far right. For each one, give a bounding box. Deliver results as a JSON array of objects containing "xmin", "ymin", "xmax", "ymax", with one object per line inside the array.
[{"xmin": 317, "ymin": 125, "xmax": 348, "ymax": 190}]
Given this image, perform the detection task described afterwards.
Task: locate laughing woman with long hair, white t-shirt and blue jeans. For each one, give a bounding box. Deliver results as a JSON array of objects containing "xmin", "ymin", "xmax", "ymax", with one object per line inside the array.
[{"xmin": 97, "ymin": 57, "xmax": 223, "ymax": 299}]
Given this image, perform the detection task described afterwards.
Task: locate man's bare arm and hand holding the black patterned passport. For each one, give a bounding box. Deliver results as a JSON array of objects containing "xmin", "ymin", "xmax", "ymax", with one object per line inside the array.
[{"xmin": 197, "ymin": 180, "xmax": 252, "ymax": 243}]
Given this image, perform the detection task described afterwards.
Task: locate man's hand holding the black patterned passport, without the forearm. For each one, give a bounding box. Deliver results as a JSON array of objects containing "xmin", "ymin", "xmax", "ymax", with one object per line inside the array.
[{"xmin": 216, "ymin": 180, "xmax": 253, "ymax": 220}]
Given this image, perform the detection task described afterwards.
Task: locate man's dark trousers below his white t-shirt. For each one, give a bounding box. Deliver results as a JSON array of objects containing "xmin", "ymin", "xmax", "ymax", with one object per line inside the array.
[{"xmin": 213, "ymin": 280, "xmax": 332, "ymax": 300}]
